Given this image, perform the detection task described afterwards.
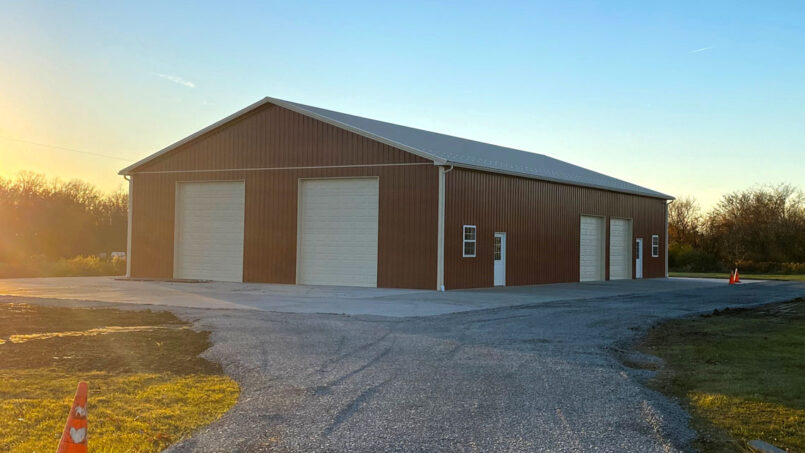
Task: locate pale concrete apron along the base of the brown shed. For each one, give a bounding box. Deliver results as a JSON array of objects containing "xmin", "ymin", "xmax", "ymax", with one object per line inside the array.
[{"xmin": 0, "ymin": 277, "xmax": 726, "ymax": 317}]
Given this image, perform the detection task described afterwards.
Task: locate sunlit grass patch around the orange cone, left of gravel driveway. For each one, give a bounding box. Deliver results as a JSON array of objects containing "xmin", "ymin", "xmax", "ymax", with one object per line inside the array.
[{"xmin": 0, "ymin": 304, "xmax": 239, "ymax": 452}]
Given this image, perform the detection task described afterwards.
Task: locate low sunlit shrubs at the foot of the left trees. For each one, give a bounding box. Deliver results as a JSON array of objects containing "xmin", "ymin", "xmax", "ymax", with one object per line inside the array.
[{"xmin": 0, "ymin": 256, "xmax": 126, "ymax": 278}]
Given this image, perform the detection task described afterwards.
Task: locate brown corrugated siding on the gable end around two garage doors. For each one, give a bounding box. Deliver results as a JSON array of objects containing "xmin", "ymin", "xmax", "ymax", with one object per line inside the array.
[{"xmin": 131, "ymin": 105, "xmax": 438, "ymax": 289}]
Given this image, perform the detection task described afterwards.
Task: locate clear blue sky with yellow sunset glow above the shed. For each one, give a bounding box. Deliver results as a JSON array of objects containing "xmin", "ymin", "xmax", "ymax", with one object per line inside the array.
[{"xmin": 0, "ymin": 1, "xmax": 805, "ymax": 206}]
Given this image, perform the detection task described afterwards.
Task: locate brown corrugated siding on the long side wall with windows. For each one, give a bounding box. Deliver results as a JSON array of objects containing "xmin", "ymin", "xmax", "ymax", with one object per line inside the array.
[{"xmin": 444, "ymin": 168, "xmax": 665, "ymax": 289}]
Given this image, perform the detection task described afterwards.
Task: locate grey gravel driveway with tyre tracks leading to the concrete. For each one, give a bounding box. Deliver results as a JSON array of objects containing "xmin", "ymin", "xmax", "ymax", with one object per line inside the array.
[{"xmin": 151, "ymin": 282, "xmax": 805, "ymax": 452}]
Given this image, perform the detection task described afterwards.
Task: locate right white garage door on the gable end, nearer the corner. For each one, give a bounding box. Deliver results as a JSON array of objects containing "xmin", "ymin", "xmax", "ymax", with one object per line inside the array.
[{"xmin": 296, "ymin": 178, "xmax": 379, "ymax": 287}]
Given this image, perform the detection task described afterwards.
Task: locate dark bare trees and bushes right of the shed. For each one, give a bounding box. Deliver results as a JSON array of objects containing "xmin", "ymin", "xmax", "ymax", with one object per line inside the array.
[{"xmin": 668, "ymin": 184, "xmax": 805, "ymax": 273}]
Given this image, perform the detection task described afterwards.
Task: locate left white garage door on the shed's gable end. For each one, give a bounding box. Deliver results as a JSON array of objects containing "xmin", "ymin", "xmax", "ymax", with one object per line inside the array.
[{"xmin": 173, "ymin": 181, "xmax": 246, "ymax": 282}]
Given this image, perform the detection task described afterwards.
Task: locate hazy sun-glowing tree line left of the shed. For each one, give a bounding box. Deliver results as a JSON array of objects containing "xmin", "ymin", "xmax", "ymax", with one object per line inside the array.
[{"xmin": 0, "ymin": 172, "xmax": 128, "ymax": 263}]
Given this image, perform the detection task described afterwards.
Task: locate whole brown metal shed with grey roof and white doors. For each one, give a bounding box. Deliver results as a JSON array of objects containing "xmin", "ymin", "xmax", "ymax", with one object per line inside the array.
[{"xmin": 121, "ymin": 98, "xmax": 672, "ymax": 289}]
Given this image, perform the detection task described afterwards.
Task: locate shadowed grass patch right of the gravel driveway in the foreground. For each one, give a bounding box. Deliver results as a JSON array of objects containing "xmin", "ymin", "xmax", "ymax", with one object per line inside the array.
[{"xmin": 639, "ymin": 298, "xmax": 805, "ymax": 452}]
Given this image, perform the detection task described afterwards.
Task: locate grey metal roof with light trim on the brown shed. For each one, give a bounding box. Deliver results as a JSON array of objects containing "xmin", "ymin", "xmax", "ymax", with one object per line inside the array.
[{"xmin": 120, "ymin": 97, "xmax": 673, "ymax": 200}]
